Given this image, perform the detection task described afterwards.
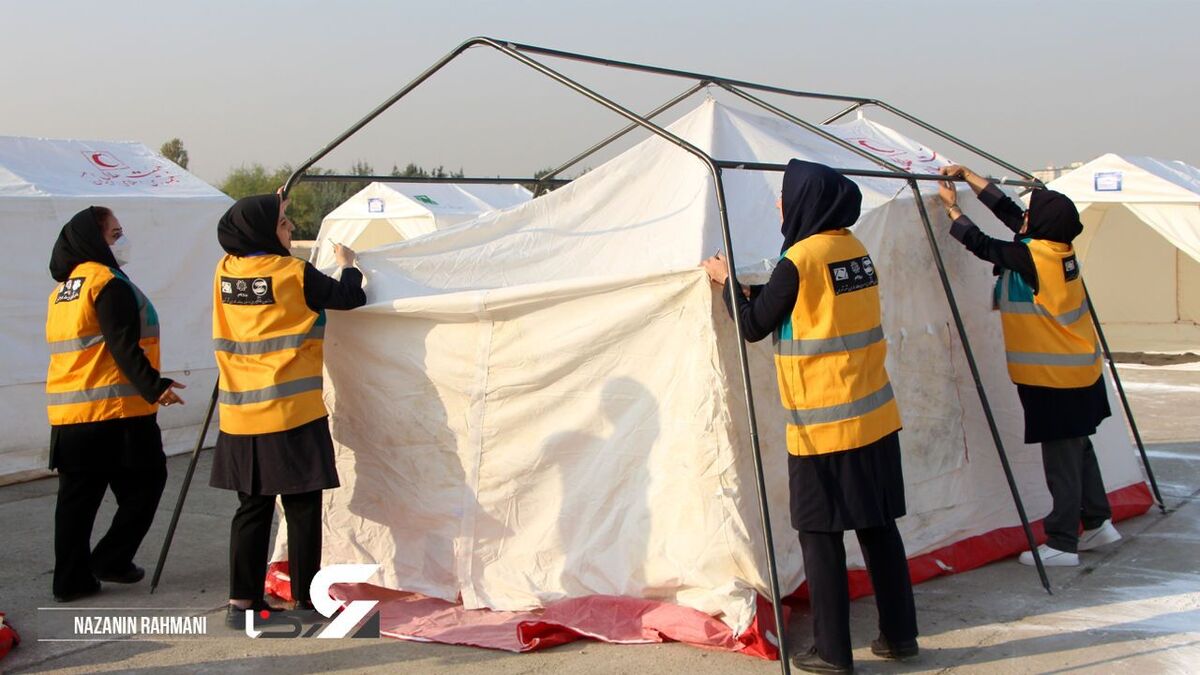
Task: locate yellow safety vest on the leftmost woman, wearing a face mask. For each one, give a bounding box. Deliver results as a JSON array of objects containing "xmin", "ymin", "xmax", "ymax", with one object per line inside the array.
[{"xmin": 46, "ymin": 262, "xmax": 160, "ymax": 425}]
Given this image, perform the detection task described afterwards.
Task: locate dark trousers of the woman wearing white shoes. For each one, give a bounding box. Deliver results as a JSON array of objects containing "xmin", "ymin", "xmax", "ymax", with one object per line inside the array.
[{"xmin": 1042, "ymin": 436, "xmax": 1112, "ymax": 552}]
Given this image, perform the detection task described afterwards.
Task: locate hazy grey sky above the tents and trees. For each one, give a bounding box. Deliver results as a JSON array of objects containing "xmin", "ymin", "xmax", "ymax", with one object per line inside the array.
[{"xmin": 0, "ymin": 0, "xmax": 1200, "ymax": 183}]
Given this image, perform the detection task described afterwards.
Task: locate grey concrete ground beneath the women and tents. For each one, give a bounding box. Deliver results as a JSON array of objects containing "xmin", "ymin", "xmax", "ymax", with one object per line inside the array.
[{"xmin": 0, "ymin": 365, "xmax": 1200, "ymax": 675}]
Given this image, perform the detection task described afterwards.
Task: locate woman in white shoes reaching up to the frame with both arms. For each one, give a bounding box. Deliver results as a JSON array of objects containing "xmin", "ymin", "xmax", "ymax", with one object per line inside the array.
[{"xmin": 938, "ymin": 165, "xmax": 1121, "ymax": 567}]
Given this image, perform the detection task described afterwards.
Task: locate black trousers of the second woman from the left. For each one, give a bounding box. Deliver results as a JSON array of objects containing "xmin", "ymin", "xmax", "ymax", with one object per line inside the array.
[{"xmin": 229, "ymin": 490, "xmax": 320, "ymax": 607}]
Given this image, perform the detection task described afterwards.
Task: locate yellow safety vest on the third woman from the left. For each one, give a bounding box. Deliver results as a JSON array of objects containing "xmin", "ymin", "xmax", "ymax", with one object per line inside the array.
[{"xmin": 775, "ymin": 229, "xmax": 900, "ymax": 455}]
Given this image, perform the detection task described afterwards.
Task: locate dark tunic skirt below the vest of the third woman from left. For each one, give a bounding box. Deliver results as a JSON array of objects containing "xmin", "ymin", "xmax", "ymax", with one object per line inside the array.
[{"xmin": 787, "ymin": 431, "xmax": 906, "ymax": 532}]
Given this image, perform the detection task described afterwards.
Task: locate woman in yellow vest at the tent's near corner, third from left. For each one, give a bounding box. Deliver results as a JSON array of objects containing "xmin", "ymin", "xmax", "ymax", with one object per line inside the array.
[{"xmin": 704, "ymin": 160, "xmax": 918, "ymax": 673}]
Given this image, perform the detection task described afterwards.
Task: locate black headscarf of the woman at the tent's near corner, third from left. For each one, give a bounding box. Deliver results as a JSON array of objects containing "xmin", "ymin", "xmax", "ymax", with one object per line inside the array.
[{"xmin": 782, "ymin": 160, "xmax": 863, "ymax": 251}]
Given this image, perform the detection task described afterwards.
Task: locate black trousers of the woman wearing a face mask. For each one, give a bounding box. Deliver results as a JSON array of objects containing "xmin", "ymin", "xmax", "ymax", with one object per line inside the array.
[{"xmin": 54, "ymin": 458, "xmax": 167, "ymax": 596}]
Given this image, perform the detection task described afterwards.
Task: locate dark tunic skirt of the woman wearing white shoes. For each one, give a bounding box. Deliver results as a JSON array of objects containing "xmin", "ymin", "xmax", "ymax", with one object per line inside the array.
[{"xmin": 1016, "ymin": 374, "xmax": 1112, "ymax": 443}]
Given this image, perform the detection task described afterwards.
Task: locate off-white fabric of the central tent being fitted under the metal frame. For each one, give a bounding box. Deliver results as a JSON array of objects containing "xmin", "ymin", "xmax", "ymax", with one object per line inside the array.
[{"xmin": 285, "ymin": 101, "xmax": 1142, "ymax": 632}]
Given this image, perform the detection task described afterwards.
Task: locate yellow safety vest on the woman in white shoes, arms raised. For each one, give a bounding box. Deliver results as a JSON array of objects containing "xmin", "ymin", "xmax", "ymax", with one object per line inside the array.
[{"xmin": 996, "ymin": 239, "xmax": 1100, "ymax": 389}]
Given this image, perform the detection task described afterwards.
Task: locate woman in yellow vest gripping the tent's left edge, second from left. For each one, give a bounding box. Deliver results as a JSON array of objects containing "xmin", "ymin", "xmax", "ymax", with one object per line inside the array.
[{"xmin": 210, "ymin": 195, "xmax": 366, "ymax": 628}]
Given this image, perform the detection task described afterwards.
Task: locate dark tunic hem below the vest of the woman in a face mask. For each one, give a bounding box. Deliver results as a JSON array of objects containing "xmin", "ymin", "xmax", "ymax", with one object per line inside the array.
[{"xmin": 49, "ymin": 414, "xmax": 167, "ymax": 472}]
